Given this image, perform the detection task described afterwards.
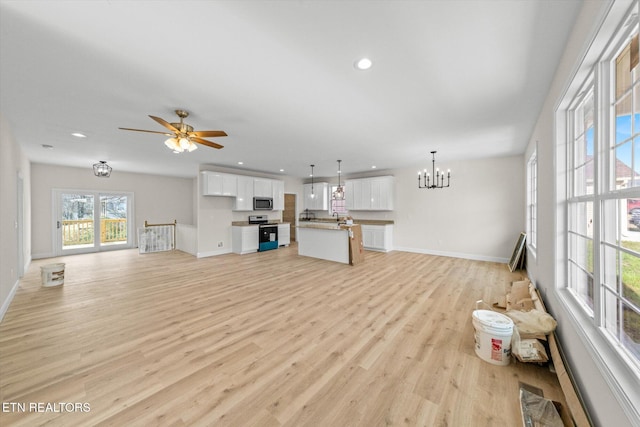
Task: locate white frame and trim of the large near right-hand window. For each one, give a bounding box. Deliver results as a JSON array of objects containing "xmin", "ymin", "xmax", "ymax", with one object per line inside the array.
[{"xmin": 554, "ymin": 0, "xmax": 640, "ymax": 420}]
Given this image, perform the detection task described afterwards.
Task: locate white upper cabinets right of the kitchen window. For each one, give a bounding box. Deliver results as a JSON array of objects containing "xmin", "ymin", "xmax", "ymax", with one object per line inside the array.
[{"xmin": 345, "ymin": 176, "xmax": 394, "ymax": 211}]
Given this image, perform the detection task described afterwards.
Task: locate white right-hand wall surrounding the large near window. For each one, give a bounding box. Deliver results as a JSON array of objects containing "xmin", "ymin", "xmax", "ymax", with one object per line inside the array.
[{"xmin": 522, "ymin": 2, "xmax": 640, "ymax": 426}]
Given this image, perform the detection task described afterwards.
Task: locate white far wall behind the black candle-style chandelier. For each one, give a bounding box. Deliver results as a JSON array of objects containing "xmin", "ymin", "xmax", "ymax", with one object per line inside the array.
[{"xmin": 308, "ymin": 156, "xmax": 525, "ymax": 263}]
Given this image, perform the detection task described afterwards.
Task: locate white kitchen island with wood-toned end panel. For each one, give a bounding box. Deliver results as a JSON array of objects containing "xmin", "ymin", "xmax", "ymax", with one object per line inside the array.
[{"xmin": 297, "ymin": 222, "xmax": 364, "ymax": 265}]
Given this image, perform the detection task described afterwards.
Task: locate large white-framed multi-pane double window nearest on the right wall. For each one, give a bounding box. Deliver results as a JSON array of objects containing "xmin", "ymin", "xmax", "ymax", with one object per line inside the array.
[{"xmin": 565, "ymin": 9, "xmax": 640, "ymax": 372}]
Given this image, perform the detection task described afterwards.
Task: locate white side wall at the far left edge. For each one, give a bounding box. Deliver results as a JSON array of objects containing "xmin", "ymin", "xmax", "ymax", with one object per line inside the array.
[{"xmin": 0, "ymin": 114, "xmax": 31, "ymax": 320}]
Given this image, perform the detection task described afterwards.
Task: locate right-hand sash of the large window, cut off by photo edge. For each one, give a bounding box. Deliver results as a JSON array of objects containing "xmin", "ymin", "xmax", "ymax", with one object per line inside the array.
[{"xmin": 600, "ymin": 28, "xmax": 640, "ymax": 364}]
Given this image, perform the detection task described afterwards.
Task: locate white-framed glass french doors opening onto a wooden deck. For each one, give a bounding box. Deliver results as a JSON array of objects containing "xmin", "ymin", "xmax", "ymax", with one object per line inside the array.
[{"xmin": 54, "ymin": 190, "xmax": 134, "ymax": 255}]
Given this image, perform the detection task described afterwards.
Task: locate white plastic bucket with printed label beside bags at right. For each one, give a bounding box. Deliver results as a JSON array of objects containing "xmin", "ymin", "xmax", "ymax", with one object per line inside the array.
[{"xmin": 472, "ymin": 310, "xmax": 513, "ymax": 366}]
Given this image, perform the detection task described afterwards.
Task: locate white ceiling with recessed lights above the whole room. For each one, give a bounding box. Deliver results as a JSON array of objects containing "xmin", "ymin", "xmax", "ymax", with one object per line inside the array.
[{"xmin": 0, "ymin": 0, "xmax": 582, "ymax": 177}]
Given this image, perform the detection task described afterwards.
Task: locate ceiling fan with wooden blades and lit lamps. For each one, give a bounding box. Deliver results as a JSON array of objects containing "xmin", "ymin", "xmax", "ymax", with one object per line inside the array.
[{"xmin": 118, "ymin": 110, "xmax": 227, "ymax": 153}]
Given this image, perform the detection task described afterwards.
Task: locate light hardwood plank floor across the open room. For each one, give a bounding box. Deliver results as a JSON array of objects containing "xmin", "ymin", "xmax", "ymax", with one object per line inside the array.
[{"xmin": 0, "ymin": 245, "xmax": 563, "ymax": 426}]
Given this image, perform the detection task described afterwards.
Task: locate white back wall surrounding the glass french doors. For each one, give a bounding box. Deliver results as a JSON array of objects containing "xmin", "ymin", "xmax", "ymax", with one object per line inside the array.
[{"xmin": 31, "ymin": 163, "xmax": 195, "ymax": 258}]
